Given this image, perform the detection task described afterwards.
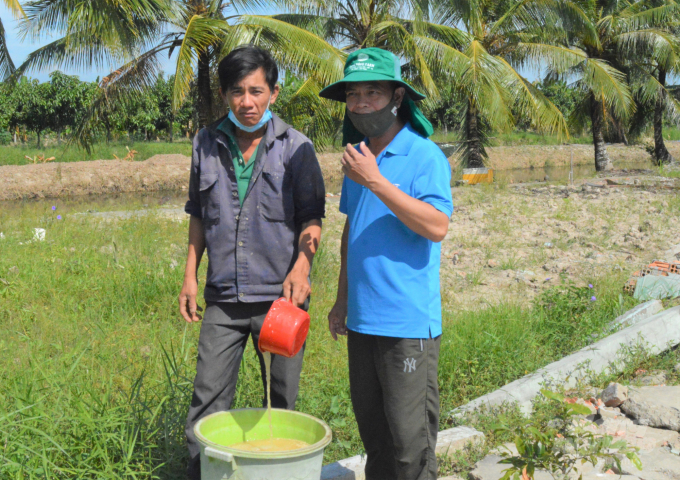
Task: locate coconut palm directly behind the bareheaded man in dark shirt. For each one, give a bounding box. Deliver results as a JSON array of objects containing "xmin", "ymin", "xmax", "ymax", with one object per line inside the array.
[{"xmin": 15, "ymin": 0, "xmax": 346, "ymax": 130}]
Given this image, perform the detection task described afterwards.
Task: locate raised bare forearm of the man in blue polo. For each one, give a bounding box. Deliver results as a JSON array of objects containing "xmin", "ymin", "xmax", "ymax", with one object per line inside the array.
[{"xmin": 370, "ymin": 177, "xmax": 449, "ymax": 242}]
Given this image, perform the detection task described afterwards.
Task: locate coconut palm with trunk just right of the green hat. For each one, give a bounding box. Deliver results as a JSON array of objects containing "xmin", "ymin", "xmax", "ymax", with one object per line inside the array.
[{"xmin": 247, "ymin": 0, "xmax": 567, "ymax": 166}]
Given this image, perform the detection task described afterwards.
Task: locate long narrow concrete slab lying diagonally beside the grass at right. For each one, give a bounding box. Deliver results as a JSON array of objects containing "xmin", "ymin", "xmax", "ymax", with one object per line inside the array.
[{"xmin": 451, "ymin": 307, "xmax": 680, "ymax": 415}]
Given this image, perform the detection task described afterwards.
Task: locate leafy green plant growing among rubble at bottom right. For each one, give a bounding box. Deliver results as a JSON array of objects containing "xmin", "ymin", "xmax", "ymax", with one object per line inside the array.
[{"xmin": 495, "ymin": 390, "xmax": 642, "ymax": 480}]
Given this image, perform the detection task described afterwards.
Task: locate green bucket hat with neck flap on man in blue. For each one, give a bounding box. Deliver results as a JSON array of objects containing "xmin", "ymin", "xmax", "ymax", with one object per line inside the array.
[{"xmin": 319, "ymin": 48, "xmax": 434, "ymax": 145}]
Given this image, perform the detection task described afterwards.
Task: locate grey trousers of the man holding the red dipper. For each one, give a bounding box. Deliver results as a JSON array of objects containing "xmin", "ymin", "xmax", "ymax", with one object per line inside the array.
[{"xmin": 186, "ymin": 302, "xmax": 304, "ymax": 480}]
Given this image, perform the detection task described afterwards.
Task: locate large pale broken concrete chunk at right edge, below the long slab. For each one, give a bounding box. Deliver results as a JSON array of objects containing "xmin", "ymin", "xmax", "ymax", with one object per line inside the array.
[{"xmin": 621, "ymin": 386, "xmax": 680, "ymax": 432}]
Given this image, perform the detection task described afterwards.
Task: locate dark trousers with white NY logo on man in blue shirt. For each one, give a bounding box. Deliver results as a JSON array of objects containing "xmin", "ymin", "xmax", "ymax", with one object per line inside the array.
[{"xmin": 347, "ymin": 330, "xmax": 441, "ymax": 480}]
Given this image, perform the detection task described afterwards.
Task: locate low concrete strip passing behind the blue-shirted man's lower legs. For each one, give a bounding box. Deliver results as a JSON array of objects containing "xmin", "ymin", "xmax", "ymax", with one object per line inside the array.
[{"xmin": 321, "ymin": 427, "xmax": 484, "ymax": 480}]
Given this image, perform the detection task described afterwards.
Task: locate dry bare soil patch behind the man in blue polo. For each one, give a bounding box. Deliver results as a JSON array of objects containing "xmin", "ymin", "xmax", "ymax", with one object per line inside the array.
[{"xmin": 324, "ymin": 172, "xmax": 680, "ymax": 310}]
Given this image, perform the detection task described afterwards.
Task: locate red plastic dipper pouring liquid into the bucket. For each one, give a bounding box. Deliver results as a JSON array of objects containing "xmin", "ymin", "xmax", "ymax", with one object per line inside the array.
[{"xmin": 257, "ymin": 298, "xmax": 309, "ymax": 358}]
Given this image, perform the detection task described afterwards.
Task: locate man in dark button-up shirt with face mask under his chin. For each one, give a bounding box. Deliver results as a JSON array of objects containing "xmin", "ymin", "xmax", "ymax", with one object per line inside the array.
[{"xmin": 179, "ymin": 45, "xmax": 326, "ymax": 480}]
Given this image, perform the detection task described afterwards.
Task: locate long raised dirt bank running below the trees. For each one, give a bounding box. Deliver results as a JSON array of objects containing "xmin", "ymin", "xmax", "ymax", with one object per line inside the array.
[{"xmin": 0, "ymin": 142, "xmax": 680, "ymax": 200}]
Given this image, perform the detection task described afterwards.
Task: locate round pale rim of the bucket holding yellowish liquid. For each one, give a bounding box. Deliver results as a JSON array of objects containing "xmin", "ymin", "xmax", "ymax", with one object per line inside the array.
[{"xmin": 194, "ymin": 408, "xmax": 333, "ymax": 458}]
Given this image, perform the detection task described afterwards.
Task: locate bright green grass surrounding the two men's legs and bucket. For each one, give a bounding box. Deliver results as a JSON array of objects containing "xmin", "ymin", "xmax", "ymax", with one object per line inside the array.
[{"xmin": 0, "ymin": 202, "xmax": 644, "ymax": 479}]
